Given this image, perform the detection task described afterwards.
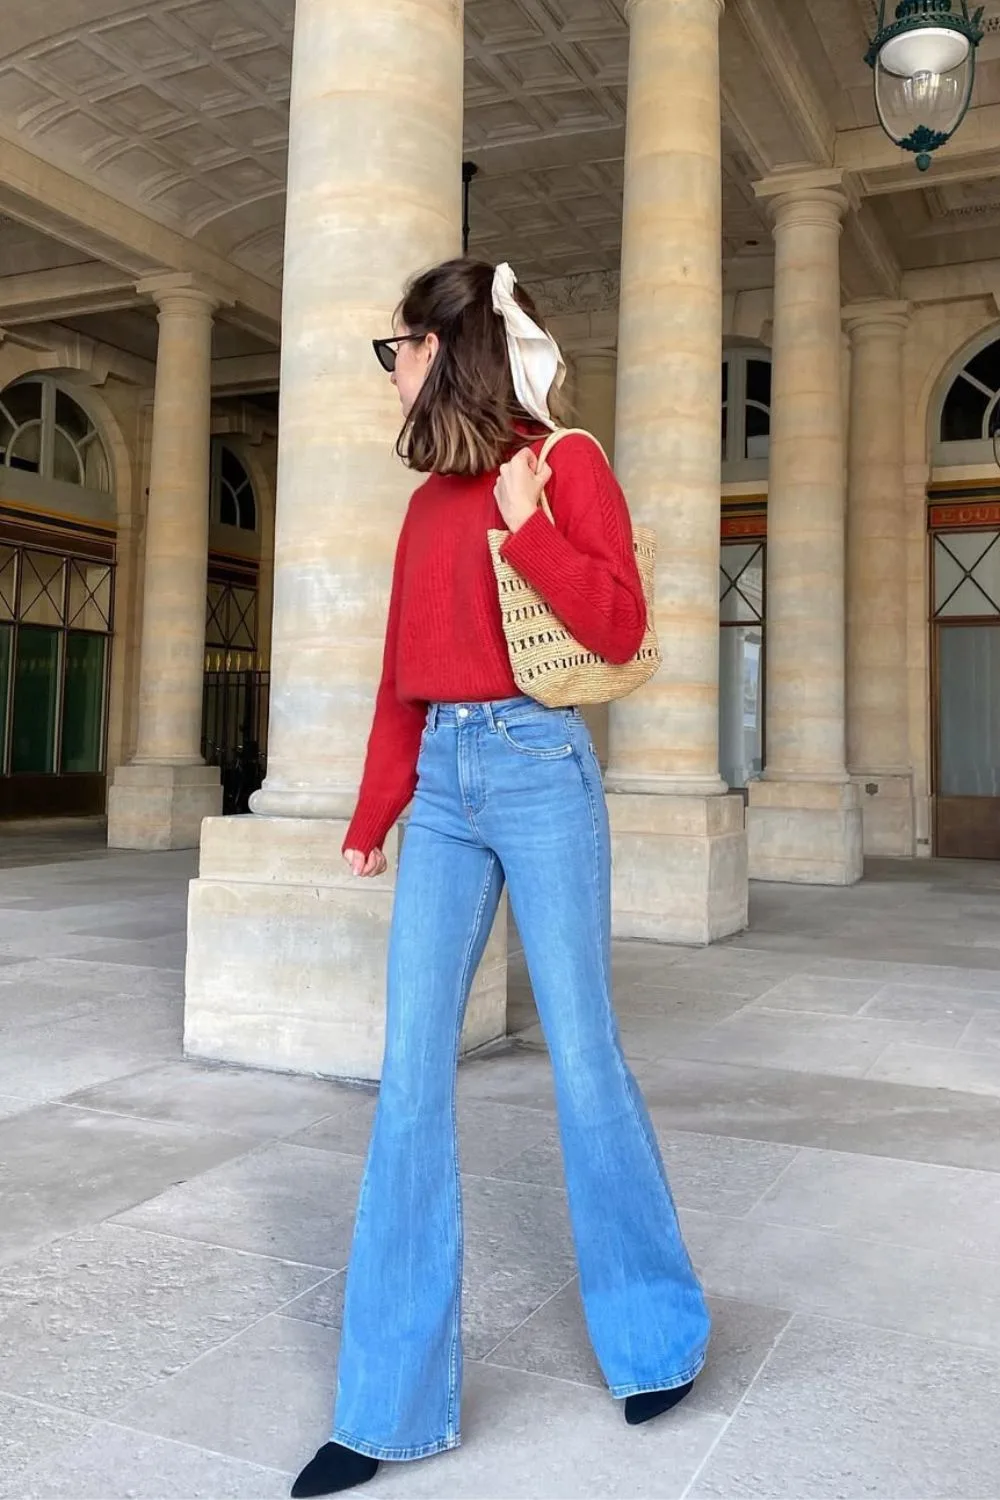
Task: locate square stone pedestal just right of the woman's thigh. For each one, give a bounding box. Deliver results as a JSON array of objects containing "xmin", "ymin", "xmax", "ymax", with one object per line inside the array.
[{"xmin": 607, "ymin": 792, "xmax": 748, "ymax": 947}]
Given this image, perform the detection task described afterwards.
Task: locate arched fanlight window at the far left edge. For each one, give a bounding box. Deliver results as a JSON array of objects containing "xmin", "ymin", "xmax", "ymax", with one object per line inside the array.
[{"xmin": 0, "ymin": 375, "xmax": 111, "ymax": 495}]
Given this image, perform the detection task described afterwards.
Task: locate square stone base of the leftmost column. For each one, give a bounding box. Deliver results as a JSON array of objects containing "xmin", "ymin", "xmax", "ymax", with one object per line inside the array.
[{"xmin": 108, "ymin": 764, "xmax": 222, "ymax": 849}]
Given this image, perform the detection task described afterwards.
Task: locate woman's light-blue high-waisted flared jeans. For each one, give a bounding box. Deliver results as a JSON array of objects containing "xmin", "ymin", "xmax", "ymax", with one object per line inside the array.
[{"xmin": 333, "ymin": 698, "xmax": 709, "ymax": 1460}]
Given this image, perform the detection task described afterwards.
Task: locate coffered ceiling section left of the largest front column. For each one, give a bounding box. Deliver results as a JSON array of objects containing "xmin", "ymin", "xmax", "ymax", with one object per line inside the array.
[{"xmin": 0, "ymin": 0, "xmax": 294, "ymax": 279}]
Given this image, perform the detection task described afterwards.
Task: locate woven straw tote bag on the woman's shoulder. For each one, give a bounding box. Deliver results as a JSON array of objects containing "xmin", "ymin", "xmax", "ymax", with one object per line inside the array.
[{"xmin": 487, "ymin": 428, "xmax": 660, "ymax": 708}]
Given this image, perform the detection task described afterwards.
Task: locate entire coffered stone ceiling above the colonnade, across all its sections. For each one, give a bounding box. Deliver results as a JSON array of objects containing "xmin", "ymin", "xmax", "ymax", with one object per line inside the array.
[{"xmin": 0, "ymin": 0, "xmax": 1000, "ymax": 360}]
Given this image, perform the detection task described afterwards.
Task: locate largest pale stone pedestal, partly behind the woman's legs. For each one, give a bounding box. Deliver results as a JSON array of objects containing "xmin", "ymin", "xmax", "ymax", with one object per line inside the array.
[{"xmin": 184, "ymin": 818, "xmax": 507, "ymax": 1080}]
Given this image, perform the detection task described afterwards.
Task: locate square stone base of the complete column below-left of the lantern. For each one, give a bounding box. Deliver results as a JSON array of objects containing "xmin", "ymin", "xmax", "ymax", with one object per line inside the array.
[{"xmin": 747, "ymin": 780, "xmax": 864, "ymax": 885}]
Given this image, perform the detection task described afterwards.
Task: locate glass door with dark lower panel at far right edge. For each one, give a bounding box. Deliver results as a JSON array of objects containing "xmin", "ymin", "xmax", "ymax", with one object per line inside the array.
[{"xmin": 934, "ymin": 531, "xmax": 1000, "ymax": 860}]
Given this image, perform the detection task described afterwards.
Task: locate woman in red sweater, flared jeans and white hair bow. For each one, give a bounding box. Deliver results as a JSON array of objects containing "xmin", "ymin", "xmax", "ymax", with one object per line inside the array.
[{"xmin": 292, "ymin": 260, "xmax": 709, "ymax": 1496}]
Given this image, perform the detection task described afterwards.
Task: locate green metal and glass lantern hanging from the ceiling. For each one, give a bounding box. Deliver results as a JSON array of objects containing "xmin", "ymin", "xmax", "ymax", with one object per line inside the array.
[{"xmin": 865, "ymin": 0, "xmax": 984, "ymax": 173}]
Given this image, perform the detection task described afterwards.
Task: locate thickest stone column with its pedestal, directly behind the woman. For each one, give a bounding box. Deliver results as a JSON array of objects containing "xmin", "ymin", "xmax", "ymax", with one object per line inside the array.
[{"xmin": 186, "ymin": 0, "xmax": 505, "ymax": 1079}]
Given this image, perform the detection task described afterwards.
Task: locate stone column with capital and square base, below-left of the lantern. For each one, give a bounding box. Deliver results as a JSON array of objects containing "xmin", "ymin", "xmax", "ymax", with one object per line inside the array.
[{"xmin": 748, "ymin": 171, "xmax": 862, "ymax": 885}]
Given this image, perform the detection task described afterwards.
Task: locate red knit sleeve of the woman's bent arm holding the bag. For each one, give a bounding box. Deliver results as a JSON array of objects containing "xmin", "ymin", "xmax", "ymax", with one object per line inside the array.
[{"xmin": 502, "ymin": 437, "xmax": 646, "ymax": 663}]
